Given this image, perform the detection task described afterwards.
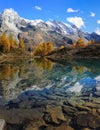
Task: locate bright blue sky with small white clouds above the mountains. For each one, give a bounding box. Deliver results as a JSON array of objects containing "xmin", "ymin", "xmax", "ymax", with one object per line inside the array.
[{"xmin": 0, "ymin": 0, "xmax": 100, "ymax": 34}]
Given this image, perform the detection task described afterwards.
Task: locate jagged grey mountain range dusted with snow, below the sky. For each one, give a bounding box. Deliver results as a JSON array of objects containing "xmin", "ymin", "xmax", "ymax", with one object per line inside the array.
[{"xmin": 0, "ymin": 9, "xmax": 100, "ymax": 46}]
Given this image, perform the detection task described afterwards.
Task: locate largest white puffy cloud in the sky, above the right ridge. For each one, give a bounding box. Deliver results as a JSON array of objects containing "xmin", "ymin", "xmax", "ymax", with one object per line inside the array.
[{"xmin": 67, "ymin": 16, "xmax": 85, "ymax": 28}]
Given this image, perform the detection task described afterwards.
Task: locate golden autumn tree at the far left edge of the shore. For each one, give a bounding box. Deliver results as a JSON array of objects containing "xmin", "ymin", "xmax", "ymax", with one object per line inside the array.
[{"xmin": 0, "ymin": 33, "xmax": 10, "ymax": 52}]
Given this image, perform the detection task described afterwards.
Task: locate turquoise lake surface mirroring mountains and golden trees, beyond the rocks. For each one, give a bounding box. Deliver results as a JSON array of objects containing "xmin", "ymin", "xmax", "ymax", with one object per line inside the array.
[{"xmin": 0, "ymin": 59, "xmax": 100, "ymax": 101}]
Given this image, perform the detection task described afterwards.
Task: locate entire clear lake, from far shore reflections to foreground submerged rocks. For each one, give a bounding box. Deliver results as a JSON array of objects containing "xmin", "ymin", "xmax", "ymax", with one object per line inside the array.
[{"xmin": 0, "ymin": 59, "xmax": 100, "ymax": 130}]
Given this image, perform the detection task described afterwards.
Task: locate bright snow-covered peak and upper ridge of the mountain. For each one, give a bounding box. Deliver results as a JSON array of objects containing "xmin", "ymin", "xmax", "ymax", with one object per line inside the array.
[{"xmin": 1, "ymin": 8, "xmax": 90, "ymax": 35}]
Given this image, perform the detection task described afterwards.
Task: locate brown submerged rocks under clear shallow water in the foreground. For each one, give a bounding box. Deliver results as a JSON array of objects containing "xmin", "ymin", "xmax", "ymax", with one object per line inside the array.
[{"xmin": 0, "ymin": 91, "xmax": 100, "ymax": 130}]
